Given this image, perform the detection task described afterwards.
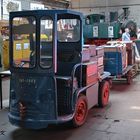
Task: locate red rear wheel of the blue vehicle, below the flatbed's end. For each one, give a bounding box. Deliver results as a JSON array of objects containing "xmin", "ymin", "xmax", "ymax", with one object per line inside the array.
[{"xmin": 98, "ymin": 81, "xmax": 110, "ymax": 107}]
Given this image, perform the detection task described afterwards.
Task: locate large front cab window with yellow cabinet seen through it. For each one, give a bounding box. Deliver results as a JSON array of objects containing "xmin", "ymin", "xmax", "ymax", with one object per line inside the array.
[{"xmin": 12, "ymin": 16, "xmax": 36, "ymax": 68}]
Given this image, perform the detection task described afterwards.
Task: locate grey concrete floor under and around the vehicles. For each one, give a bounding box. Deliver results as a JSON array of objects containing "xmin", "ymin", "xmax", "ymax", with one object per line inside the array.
[{"xmin": 0, "ymin": 75, "xmax": 140, "ymax": 140}]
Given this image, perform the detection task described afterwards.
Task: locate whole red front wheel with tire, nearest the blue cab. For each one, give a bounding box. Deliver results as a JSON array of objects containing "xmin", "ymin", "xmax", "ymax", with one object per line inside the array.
[{"xmin": 72, "ymin": 95, "xmax": 88, "ymax": 127}]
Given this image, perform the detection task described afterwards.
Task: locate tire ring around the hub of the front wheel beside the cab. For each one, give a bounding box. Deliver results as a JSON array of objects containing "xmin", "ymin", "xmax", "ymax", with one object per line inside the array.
[{"xmin": 71, "ymin": 95, "xmax": 88, "ymax": 128}]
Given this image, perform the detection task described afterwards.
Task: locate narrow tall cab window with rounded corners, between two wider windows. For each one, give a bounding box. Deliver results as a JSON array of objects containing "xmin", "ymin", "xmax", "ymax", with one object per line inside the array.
[{"xmin": 40, "ymin": 17, "xmax": 53, "ymax": 68}]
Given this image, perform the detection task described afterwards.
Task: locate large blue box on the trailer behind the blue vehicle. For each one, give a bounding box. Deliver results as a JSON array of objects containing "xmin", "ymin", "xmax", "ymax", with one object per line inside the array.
[{"xmin": 104, "ymin": 44, "xmax": 127, "ymax": 76}]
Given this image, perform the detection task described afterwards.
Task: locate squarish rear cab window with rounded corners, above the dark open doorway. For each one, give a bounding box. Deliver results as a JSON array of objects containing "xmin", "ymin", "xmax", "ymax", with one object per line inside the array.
[{"xmin": 57, "ymin": 19, "xmax": 80, "ymax": 42}]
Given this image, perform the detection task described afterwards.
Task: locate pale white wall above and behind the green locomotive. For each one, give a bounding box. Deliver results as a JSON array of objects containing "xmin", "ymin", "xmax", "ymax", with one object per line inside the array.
[{"xmin": 72, "ymin": 0, "xmax": 140, "ymax": 26}]
